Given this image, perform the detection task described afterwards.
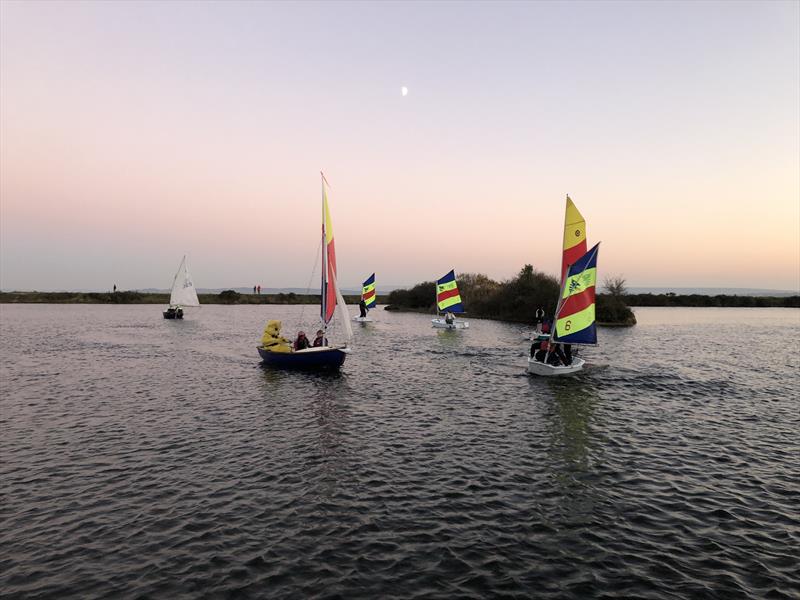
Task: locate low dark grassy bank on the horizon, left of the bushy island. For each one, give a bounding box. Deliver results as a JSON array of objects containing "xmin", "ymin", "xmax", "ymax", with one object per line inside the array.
[{"xmin": 0, "ymin": 290, "xmax": 386, "ymax": 305}]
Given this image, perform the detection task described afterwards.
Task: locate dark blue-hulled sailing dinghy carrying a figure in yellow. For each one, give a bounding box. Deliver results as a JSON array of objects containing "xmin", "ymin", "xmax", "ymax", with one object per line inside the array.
[{"xmin": 258, "ymin": 173, "xmax": 353, "ymax": 370}]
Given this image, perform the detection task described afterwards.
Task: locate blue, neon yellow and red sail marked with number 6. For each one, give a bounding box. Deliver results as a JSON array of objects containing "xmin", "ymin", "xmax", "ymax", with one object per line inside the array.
[{"xmin": 553, "ymin": 243, "xmax": 600, "ymax": 344}]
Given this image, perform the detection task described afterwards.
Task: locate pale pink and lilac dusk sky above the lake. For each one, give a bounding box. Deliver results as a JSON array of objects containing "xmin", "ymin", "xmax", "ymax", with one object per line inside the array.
[{"xmin": 0, "ymin": 0, "xmax": 800, "ymax": 291}]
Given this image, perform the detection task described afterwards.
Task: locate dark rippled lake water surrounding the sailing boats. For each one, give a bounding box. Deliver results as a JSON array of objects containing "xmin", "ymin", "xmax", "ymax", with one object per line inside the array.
[{"xmin": 0, "ymin": 305, "xmax": 800, "ymax": 599}]
